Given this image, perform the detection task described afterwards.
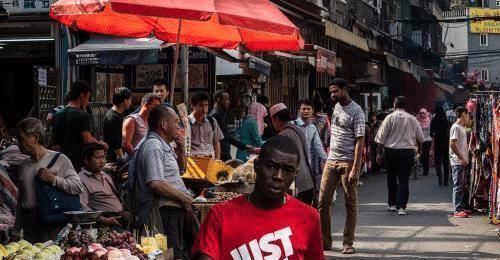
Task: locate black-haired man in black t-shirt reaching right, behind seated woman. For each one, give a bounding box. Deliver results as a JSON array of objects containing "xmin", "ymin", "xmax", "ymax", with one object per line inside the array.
[{"xmin": 54, "ymin": 81, "xmax": 108, "ymax": 172}]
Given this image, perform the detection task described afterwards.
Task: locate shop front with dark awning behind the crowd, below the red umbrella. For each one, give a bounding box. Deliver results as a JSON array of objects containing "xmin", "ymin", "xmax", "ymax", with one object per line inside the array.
[{"xmin": 67, "ymin": 36, "xmax": 215, "ymax": 137}]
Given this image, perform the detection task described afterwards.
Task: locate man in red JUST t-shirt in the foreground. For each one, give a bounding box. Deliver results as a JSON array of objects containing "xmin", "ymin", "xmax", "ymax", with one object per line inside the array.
[{"xmin": 192, "ymin": 136, "xmax": 325, "ymax": 260}]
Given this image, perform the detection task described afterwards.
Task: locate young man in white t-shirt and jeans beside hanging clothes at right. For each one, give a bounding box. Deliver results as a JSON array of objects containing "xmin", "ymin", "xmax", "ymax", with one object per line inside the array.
[{"xmin": 450, "ymin": 107, "xmax": 470, "ymax": 218}]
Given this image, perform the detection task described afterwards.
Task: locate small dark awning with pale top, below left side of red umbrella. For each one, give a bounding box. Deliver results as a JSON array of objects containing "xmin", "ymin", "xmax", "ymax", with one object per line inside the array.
[{"xmin": 68, "ymin": 36, "xmax": 166, "ymax": 66}]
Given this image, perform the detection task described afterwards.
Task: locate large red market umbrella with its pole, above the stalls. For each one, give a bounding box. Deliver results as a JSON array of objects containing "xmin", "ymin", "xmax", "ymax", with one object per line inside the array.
[{"xmin": 50, "ymin": 0, "xmax": 304, "ymax": 102}]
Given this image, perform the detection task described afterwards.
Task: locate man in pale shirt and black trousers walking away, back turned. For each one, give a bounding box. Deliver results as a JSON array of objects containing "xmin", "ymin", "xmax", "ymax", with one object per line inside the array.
[{"xmin": 375, "ymin": 96, "xmax": 424, "ymax": 216}]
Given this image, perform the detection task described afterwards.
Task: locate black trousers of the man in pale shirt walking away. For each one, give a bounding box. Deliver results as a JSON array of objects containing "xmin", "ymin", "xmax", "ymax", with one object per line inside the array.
[{"xmin": 385, "ymin": 148, "xmax": 415, "ymax": 209}]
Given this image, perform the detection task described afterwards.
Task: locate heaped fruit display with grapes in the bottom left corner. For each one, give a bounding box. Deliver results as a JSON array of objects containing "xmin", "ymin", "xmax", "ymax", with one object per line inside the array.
[{"xmin": 0, "ymin": 212, "xmax": 172, "ymax": 260}]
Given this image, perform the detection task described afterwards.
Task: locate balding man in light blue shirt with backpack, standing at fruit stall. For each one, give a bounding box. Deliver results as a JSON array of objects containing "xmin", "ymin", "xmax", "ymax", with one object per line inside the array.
[{"xmin": 129, "ymin": 106, "xmax": 192, "ymax": 259}]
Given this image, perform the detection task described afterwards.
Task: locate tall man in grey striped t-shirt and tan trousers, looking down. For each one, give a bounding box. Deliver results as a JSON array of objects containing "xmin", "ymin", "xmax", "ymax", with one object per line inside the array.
[{"xmin": 318, "ymin": 78, "xmax": 365, "ymax": 254}]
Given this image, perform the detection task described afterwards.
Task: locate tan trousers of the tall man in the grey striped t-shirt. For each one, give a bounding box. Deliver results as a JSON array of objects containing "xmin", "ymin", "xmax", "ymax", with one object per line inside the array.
[{"xmin": 318, "ymin": 160, "xmax": 358, "ymax": 247}]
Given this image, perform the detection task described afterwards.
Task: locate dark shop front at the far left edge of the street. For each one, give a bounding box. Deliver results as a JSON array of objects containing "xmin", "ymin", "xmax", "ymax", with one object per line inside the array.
[{"xmin": 0, "ymin": 0, "xmax": 57, "ymax": 128}]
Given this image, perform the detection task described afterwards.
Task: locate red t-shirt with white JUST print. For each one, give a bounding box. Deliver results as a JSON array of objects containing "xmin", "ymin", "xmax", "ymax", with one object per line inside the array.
[{"xmin": 193, "ymin": 195, "xmax": 325, "ymax": 260}]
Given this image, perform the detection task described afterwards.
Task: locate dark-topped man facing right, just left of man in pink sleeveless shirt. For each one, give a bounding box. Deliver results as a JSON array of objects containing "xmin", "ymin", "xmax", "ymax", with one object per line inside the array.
[{"xmin": 102, "ymin": 88, "xmax": 132, "ymax": 162}]
